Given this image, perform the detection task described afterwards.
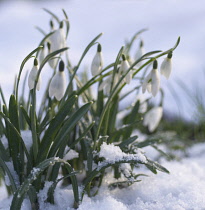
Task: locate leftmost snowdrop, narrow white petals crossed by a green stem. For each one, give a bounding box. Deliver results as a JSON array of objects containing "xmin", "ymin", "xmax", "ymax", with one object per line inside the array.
[{"xmin": 28, "ymin": 58, "xmax": 41, "ymax": 90}]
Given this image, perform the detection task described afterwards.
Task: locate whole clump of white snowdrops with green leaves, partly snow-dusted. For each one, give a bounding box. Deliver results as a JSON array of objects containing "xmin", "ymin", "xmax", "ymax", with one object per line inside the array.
[{"xmin": 0, "ymin": 10, "xmax": 179, "ymax": 210}]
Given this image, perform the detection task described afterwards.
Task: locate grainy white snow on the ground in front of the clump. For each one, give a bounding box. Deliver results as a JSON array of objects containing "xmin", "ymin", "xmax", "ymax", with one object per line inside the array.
[{"xmin": 0, "ymin": 140, "xmax": 205, "ymax": 210}]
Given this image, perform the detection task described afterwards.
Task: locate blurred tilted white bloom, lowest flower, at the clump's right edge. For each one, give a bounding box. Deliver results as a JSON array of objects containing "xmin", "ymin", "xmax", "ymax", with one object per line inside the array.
[{"xmin": 143, "ymin": 106, "xmax": 163, "ymax": 132}]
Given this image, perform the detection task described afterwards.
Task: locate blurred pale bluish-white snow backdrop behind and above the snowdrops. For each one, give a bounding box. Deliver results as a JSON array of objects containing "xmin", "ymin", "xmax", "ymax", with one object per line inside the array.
[{"xmin": 0, "ymin": 0, "xmax": 205, "ymax": 119}]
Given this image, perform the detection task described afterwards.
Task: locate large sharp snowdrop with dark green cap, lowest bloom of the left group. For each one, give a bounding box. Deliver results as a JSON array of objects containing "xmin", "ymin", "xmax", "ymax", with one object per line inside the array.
[{"xmin": 48, "ymin": 60, "xmax": 65, "ymax": 101}]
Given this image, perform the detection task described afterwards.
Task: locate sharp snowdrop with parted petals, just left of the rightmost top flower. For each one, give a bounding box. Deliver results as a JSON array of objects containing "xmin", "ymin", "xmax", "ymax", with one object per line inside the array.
[{"xmin": 142, "ymin": 60, "xmax": 160, "ymax": 96}]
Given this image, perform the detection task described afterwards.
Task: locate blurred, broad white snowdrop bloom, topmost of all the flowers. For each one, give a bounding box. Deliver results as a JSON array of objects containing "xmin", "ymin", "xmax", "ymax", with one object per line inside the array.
[{"xmin": 49, "ymin": 22, "xmax": 66, "ymax": 52}]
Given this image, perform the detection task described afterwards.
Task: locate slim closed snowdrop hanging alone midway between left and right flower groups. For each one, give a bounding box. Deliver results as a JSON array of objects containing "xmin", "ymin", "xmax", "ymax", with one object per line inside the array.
[{"xmin": 91, "ymin": 44, "xmax": 103, "ymax": 77}]
